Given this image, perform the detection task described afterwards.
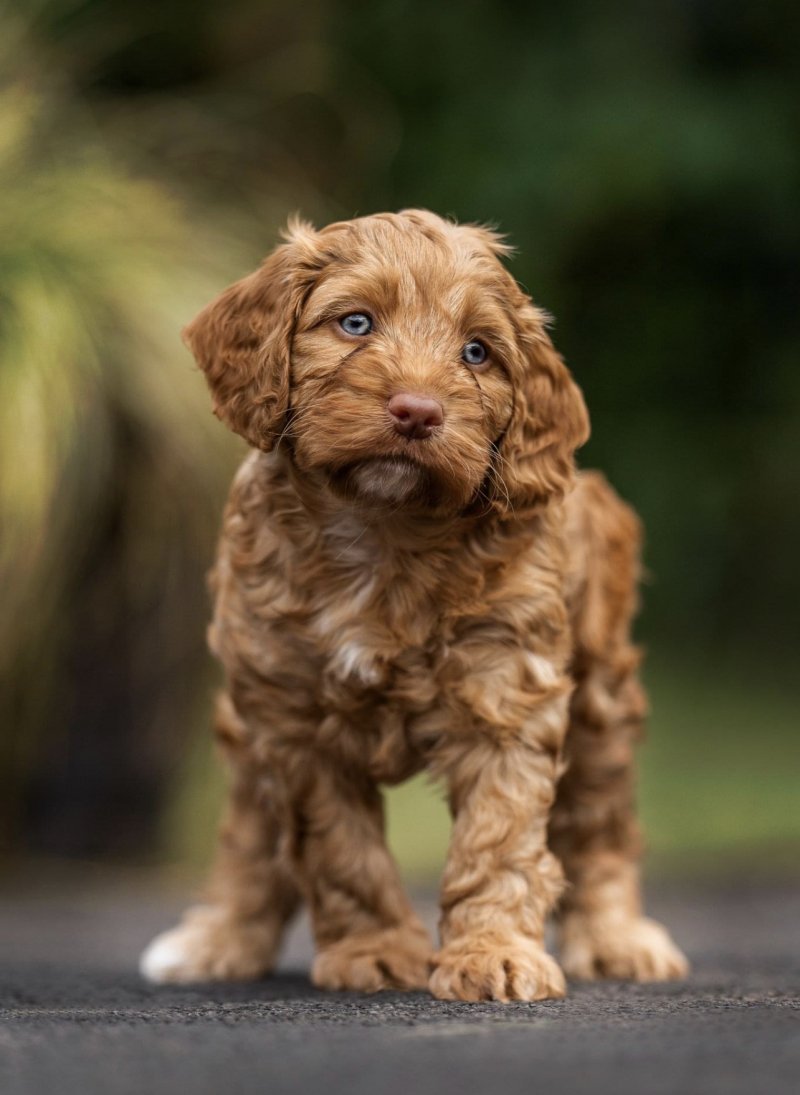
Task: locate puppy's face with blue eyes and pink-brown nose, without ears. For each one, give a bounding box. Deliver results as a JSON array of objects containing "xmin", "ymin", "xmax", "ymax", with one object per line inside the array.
[{"xmin": 291, "ymin": 217, "xmax": 523, "ymax": 511}]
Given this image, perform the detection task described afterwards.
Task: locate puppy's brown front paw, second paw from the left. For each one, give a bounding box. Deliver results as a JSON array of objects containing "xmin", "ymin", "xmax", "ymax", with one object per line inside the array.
[{"xmin": 311, "ymin": 926, "xmax": 432, "ymax": 992}]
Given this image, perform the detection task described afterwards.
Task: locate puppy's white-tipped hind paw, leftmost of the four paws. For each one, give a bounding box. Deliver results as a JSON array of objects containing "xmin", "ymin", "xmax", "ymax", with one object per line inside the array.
[{"xmin": 139, "ymin": 906, "xmax": 278, "ymax": 984}]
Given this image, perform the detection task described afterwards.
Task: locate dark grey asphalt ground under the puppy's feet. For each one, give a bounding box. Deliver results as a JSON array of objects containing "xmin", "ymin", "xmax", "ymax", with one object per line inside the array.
[{"xmin": 0, "ymin": 873, "xmax": 800, "ymax": 1095}]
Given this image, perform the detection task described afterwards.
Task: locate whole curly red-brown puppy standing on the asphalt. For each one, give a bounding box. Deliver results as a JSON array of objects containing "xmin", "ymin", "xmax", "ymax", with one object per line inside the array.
[{"xmin": 141, "ymin": 210, "xmax": 686, "ymax": 1001}]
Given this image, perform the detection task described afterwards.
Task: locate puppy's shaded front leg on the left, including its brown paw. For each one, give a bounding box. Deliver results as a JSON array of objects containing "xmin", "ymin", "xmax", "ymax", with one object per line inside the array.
[{"xmin": 298, "ymin": 757, "xmax": 432, "ymax": 992}]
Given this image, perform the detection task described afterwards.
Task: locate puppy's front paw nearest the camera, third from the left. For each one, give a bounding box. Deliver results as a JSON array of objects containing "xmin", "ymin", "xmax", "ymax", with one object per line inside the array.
[{"xmin": 430, "ymin": 938, "xmax": 567, "ymax": 1003}]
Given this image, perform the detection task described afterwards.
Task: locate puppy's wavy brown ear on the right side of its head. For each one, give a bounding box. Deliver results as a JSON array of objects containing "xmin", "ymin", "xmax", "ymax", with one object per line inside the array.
[{"xmin": 496, "ymin": 297, "xmax": 589, "ymax": 516}]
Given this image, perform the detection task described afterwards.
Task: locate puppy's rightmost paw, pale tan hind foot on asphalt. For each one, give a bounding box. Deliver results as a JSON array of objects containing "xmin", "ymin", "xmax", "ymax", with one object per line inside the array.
[{"xmin": 560, "ymin": 915, "xmax": 688, "ymax": 981}]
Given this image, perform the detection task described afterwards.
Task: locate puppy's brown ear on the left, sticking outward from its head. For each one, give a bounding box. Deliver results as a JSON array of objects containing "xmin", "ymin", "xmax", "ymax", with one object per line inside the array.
[{"xmin": 183, "ymin": 222, "xmax": 315, "ymax": 452}]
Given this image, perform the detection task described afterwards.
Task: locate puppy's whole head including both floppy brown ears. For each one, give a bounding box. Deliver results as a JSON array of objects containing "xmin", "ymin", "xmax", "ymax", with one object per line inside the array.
[{"xmin": 184, "ymin": 210, "xmax": 589, "ymax": 516}]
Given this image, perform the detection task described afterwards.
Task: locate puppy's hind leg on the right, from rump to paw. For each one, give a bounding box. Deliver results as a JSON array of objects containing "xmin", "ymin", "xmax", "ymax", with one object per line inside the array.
[{"xmin": 548, "ymin": 475, "xmax": 688, "ymax": 981}]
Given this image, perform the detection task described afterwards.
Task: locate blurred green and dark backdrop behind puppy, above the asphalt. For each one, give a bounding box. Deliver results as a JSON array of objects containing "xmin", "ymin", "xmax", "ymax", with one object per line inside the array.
[{"xmin": 0, "ymin": 0, "xmax": 800, "ymax": 880}]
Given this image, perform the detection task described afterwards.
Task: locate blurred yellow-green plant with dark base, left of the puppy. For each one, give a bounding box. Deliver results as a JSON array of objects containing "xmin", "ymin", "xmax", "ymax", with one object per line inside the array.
[{"xmin": 0, "ymin": 4, "xmax": 244, "ymax": 852}]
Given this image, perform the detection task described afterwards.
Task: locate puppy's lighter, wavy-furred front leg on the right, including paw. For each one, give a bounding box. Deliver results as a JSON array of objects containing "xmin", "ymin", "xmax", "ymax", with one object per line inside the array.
[{"xmin": 430, "ymin": 653, "xmax": 569, "ymax": 1001}]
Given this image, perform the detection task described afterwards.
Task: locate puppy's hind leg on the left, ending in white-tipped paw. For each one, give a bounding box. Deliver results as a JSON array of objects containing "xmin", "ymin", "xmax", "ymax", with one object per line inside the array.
[{"xmin": 140, "ymin": 695, "xmax": 300, "ymax": 982}]
